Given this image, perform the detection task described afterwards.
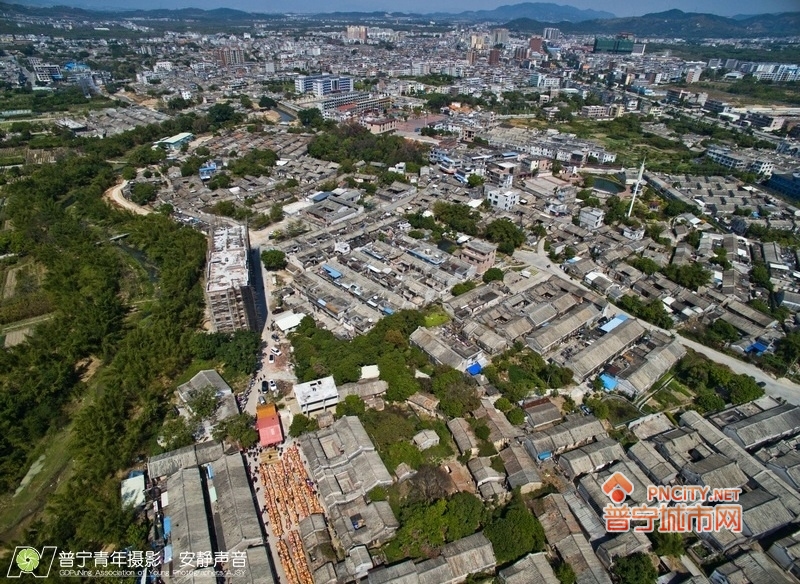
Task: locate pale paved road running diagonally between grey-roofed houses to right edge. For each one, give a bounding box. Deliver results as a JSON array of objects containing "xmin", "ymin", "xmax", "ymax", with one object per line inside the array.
[{"xmin": 514, "ymin": 240, "xmax": 800, "ymax": 404}]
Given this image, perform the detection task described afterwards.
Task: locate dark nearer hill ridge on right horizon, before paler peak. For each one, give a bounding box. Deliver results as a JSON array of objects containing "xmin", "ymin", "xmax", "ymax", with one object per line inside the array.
[{"xmin": 505, "ymin": 10, "xmax": 800, "ymax": 38}]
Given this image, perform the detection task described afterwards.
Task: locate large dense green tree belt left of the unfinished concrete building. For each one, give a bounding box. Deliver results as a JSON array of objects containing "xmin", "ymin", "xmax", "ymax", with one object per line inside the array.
[{"xmin": 0, "ymin": 156, "xmax": 206, "ymax": 550}]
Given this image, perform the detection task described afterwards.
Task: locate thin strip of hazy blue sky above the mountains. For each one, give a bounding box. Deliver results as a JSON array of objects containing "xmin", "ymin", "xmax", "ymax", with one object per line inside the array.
[{"xmin": 75, "ymin": 0, "xmax": 800, "ymax": 16}]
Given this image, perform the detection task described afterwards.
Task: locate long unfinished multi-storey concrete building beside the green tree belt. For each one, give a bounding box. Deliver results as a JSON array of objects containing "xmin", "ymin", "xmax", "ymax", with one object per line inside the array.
[{"xmin": 206, "ymin": 225, "xmax": 257, "ymax": 333}]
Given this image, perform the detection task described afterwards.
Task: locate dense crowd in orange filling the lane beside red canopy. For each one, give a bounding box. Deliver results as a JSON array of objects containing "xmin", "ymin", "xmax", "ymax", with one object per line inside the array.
[{"xmin": 260, "ymin": 445, "xmax": 323, "ymax": 584}]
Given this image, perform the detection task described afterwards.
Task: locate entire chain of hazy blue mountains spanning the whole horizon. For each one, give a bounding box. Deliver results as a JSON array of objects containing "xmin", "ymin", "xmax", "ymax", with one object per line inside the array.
[{"xmin": 0, "ymin": 0, "xmax": 800, "ymax": 39}]
